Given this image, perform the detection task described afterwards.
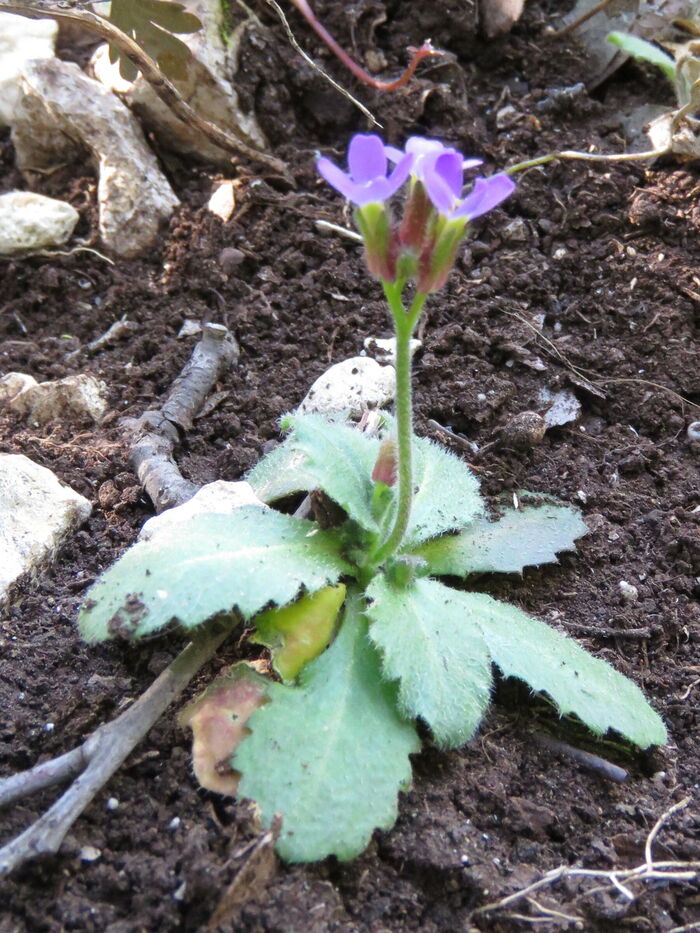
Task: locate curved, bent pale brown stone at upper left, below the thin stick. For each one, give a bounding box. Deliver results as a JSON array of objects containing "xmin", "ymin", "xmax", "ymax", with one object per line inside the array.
[{"xmin": 12, "ymin": 58, "xmax": 179, "ymax": 258}]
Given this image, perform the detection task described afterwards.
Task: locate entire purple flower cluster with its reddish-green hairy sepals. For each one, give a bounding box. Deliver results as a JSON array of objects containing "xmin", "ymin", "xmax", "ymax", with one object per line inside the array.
[{"xmin": 316, "ymin": 133, "xmax": 515, "ymax": 294}]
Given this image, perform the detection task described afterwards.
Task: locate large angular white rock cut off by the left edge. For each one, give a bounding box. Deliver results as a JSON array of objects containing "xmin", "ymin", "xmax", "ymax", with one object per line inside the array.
[{"xmin": 0, "ymin": 454, "xmax": 92, "ymax": 600}]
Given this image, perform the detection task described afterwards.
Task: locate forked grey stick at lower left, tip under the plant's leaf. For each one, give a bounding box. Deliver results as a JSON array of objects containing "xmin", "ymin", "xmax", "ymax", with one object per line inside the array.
[{"xmin": 0, "ymin": 616, "xmax": 235, "ymax": 875}]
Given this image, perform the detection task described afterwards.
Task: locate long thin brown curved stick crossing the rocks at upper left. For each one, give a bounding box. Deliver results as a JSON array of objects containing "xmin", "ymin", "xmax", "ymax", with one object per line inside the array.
[{"xmin": 0, "ymin": 0, "xmax": 291, "ymax": 181}]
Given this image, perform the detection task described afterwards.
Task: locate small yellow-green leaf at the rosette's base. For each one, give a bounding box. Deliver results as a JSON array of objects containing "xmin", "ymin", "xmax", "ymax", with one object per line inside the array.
[{"xmin": 252, "ymin": 583, "xmax": 345, "ymax": 680}]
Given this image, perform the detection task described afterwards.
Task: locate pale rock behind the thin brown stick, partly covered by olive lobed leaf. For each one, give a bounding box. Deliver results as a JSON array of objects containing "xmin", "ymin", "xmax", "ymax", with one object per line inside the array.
[{"xmin": 91, "ymin": 0, "xmax": 266, "ymax": 166}]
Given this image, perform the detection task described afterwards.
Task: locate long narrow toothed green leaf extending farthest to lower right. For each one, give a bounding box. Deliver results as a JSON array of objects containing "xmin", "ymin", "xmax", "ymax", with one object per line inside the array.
[{"xmin": 456, "ymin": 593, "xmax": 666, "ymax": 748}]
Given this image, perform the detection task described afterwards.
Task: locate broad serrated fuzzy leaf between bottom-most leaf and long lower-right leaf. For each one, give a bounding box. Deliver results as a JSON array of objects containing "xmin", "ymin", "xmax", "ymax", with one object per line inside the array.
[{"xmin": 367, "ymin": 577, "xmax": 492, "ymax": 748}]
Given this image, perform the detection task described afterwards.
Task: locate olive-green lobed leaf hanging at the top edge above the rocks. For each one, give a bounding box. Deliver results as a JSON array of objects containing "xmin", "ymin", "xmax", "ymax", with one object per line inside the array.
[{"xmin": 109, "ymin": 0, "xmax": 202, "ymax": 81}]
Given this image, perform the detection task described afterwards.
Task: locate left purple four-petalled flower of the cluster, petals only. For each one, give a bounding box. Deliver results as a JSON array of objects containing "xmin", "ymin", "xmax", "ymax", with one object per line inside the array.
[{"xmin": 316, "ymin": 133, "xmax": 413, "ymax": 207}]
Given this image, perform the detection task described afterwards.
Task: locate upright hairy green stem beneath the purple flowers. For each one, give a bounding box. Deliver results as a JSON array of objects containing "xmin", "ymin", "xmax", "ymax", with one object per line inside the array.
[{"xmin": 373, "ymin": 282, "xmax": 428, "ymax": 566}]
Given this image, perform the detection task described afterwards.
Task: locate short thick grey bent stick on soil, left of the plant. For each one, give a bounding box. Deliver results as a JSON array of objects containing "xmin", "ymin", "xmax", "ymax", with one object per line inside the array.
[{"xmin": 123, "ymin": 324, "xmax": 238, "ymax": 513}]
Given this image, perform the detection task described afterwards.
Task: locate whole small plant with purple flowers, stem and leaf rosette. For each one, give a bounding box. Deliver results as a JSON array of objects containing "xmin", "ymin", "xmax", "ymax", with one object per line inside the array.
[{"xmin": 80, "ymin": 135, "xmax": 666, "ymax": 862}]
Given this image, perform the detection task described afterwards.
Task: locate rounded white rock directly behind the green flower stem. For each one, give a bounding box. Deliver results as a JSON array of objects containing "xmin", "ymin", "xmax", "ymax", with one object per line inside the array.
[{"xmin": 297, "ymin": 356, "xmax": 396, "ymax": 415}]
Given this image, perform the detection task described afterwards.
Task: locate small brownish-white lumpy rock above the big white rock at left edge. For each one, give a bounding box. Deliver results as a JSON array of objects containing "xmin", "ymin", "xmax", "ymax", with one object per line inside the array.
[{"xmin": 9, "ymin": 374, "xmax": 107, "ymax": 424}]
